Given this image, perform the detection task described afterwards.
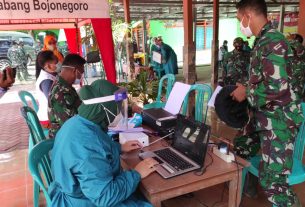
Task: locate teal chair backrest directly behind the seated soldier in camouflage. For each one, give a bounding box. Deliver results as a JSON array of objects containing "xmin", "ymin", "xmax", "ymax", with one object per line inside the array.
[{"xmin": 20, "ymin": 106, "xmax": 46, "ymax": 145}]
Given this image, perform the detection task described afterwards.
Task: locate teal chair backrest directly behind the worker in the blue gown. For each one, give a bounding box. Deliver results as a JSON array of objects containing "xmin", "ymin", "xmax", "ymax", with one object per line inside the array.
[{"xmin": 29, "ymin": 139, "xmax": 54, "ymax": 206}]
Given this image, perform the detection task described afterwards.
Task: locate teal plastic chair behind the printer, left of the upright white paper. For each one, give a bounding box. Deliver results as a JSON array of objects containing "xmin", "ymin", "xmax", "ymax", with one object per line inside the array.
[{"xmin": 143, "ymin": 74, "xmax": 176, "ymax": 109}]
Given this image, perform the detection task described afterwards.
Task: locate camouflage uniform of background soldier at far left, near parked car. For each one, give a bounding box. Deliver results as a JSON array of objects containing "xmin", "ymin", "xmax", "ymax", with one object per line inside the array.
[{"xmin": 7, "ymin": 46, "xmax": 27, "ymax": 81}]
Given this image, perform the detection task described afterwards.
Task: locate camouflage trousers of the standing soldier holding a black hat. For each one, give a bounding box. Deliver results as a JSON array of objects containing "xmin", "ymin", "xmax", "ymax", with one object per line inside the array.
[{"xmin": 259, "ymin": 128, "xmax": 298, "ymax": 207}]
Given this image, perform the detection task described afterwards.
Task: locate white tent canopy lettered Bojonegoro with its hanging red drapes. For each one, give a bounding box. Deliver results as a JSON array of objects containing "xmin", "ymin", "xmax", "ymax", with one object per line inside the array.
[{"xmin": 0, "ymin": 0, "xmax": 116, "ymax": 83}]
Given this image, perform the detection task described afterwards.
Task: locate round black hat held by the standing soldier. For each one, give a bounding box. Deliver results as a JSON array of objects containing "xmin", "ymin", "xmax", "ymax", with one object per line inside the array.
[{"xmin": 214, "ymin": 85, "xmax": 249, "ymax": 129}]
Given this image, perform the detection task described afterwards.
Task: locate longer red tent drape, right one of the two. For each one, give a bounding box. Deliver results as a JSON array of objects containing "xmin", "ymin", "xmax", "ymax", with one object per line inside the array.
[{"xmin": 91, "ymin": 18, "xmax": 116, "ymax": 83}]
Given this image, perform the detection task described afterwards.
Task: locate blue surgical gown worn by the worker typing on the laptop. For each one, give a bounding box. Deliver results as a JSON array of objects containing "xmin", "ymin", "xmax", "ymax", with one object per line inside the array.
[{"xmin": 49, "ymin": 115, "xmax": 151, "ymax": 207}]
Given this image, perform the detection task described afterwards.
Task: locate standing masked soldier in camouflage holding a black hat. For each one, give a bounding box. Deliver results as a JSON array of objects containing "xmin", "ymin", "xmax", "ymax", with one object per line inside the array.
[{"xmin": 232, "ymin": 0, "xmax": 303, "ymax": 207}]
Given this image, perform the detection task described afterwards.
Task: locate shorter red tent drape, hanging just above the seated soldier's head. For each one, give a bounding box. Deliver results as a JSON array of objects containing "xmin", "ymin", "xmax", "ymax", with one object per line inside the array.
[{"xmin": 64, "ymin": 28, "xmax": 83, "ymax": 56}]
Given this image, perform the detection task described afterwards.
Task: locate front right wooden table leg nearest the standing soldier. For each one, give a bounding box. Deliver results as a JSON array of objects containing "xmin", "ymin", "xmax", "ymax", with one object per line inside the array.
[{"xmin": 228, "ymin": 169, "xmax": 242, "ymax": 207}]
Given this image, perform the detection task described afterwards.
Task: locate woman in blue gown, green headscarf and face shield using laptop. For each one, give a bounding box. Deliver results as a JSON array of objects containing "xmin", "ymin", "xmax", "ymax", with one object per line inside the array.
[{"xmin": 49, "ymin": 80, "xmax": 157, "ymax": 207}]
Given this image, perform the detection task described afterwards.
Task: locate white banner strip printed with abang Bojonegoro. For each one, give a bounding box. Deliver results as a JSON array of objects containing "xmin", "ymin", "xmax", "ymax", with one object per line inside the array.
[{"xmin": 0, "ymin": 0, "xmax": 109, "ymax": 19}]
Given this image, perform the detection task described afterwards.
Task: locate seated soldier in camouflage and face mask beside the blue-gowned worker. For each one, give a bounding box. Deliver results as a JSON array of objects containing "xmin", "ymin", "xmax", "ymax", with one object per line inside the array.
[{"xmin": 48, "ymin": 54, "xmax": 86, "ymax": 138}]
